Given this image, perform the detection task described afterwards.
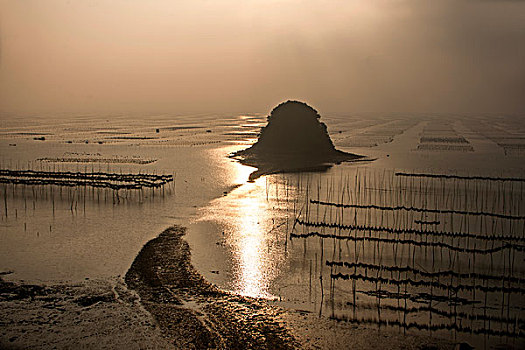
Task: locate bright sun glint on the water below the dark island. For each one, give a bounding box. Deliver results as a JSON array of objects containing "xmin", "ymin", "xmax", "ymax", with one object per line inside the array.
[{"xmin": 202, "ymin": 157, "xmax": 284, "ymax": 298}]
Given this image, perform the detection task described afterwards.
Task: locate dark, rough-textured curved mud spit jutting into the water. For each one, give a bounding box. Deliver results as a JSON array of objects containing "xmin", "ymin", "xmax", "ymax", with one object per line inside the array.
[{"xmin": 125, "ymin": 226, "xmax": 298, "ymax": 349}]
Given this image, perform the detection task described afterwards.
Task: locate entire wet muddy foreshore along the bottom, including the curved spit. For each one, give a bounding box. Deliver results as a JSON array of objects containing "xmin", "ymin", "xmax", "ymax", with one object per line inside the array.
[{"xmin": 0, "ymin": 226, "xmax": 455, "ymax": 350}]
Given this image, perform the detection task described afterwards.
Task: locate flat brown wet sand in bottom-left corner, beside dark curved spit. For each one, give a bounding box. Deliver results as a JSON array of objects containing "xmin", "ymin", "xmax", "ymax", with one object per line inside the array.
[{"xmin": 0, "ymin": 279, "xmax": 173, "ymax": 349}]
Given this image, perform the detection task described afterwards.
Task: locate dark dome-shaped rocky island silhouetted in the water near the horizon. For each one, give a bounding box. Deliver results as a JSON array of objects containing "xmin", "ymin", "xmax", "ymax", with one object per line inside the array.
[{"xmin": 231, "ymin": 100, "xmax": 365, "ymax": 180}]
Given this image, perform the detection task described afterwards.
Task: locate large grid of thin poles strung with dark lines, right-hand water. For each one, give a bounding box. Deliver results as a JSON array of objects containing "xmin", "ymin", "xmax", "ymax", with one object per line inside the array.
[{"xmin": 289, "ymin": 169, "xmax": 525, "ymax": 342}]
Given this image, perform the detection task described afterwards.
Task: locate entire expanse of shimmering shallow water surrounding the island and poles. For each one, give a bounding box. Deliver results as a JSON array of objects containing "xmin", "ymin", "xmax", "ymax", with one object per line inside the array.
[{"xmin": 0, "ymin": 115, "xmax": 525, "ymax": 345}]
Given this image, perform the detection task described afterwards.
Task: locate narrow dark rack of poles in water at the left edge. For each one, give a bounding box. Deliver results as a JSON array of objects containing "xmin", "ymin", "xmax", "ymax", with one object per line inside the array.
[{"xmin": 0, "ymin": 163, "xmax": 174, "ymax": 218}]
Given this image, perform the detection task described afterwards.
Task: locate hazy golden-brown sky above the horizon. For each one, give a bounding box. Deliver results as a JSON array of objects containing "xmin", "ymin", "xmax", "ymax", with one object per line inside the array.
[{"xmin": 0, "ymin": 0, "xmax": 525, "ymax": 113}]
